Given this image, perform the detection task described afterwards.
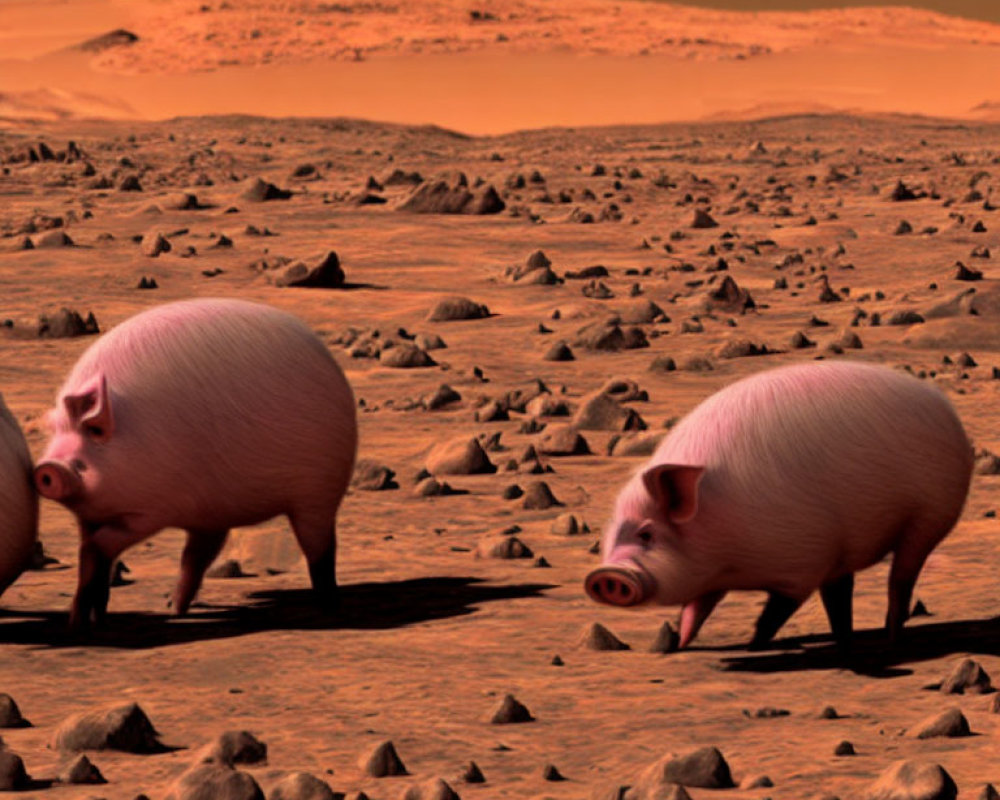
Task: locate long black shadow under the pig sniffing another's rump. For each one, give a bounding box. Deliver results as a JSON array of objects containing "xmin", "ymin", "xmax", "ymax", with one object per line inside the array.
[{"xmin": 0, "ymin": 577, "xmax": 555, "ymax": 650}]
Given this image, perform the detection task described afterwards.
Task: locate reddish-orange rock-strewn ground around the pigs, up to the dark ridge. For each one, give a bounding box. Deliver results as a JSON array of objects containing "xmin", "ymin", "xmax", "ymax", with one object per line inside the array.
[{"xmin": 0, "ymin": 116, "xmax": 1000, "ymax": 800}]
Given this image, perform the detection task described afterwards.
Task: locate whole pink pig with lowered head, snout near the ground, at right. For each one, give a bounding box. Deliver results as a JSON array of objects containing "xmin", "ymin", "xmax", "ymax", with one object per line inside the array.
[{"xmin": 586, "ymin": 362, "xmax": 973, "ymax": 648}]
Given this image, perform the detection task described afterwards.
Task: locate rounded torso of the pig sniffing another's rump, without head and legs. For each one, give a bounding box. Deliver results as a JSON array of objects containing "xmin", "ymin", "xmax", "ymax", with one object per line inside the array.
[{"xmin": 63, "ymin": 299, "xmax": 357, "ymax": 525}]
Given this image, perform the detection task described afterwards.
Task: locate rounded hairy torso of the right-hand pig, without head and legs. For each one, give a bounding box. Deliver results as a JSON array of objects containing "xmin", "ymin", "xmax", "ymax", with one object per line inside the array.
[{"xmin": 654, "ymin": 362, "xmax": 972, "ymax": 588}]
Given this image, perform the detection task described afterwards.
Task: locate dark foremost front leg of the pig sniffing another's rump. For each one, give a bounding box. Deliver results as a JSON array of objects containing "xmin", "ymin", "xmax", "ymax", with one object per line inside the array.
[{"xmin": 69, "ymin": 522, "xmax": 153, "ymax": 630}]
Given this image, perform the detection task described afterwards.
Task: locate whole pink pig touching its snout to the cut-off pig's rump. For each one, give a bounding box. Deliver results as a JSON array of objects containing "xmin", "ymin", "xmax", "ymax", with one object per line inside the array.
[{"xmin": 35, "ymin": 299, "xmax": 357, "ymax": 626}]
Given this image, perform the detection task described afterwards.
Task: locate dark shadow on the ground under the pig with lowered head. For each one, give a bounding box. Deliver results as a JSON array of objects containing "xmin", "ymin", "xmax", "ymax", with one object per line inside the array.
[{"xmin": 722, "ymin": 617, "xmax": 1000, "ymax": 678}]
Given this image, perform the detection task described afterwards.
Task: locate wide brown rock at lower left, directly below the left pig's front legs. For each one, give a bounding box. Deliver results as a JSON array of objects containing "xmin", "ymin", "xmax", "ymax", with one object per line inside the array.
[{"xmin": 54, "ymin": 703, "xmax": 165, "ymax": 753}]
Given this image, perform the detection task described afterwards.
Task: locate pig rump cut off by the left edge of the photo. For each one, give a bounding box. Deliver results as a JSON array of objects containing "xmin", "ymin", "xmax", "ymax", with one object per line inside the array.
[{"xmin": 0, "ymin": 397, "xmax": 38, "ymax": 594}]
